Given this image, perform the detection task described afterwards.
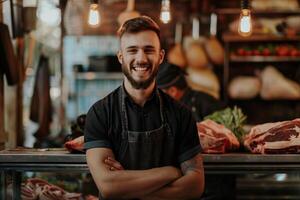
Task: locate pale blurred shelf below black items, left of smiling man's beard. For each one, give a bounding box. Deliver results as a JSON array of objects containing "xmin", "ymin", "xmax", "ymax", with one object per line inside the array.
[{"xmin": 75, "ymin": 72, "xmax": 123, "ymax": 80}]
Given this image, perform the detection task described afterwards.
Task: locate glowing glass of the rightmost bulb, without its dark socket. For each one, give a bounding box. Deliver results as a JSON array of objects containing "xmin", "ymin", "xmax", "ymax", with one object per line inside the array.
[{"xmin": 238, "ymin": 9, "xmax": 252, "ymax": 36}]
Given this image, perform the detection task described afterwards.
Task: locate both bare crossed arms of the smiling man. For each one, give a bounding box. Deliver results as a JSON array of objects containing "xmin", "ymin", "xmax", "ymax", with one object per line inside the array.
[{"xmin": 87, "ymin": 148, "xmax": 204, "ymax": 199}]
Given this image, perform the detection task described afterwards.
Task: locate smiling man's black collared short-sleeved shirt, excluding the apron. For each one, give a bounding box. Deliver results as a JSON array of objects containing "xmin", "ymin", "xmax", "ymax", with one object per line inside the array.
[{"xmin": 84, "ymin": 87, "xmax": 201, "ymax": 164}]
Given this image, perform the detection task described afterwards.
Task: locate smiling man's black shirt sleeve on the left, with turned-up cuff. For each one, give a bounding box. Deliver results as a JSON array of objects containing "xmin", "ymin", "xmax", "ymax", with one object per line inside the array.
[{"xmin": 84, "ymin": 104, "xmax": 112, "ymax": 149}]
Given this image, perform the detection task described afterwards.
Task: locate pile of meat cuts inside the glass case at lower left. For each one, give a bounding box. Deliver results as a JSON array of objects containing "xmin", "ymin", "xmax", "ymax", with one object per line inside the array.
[{"xmin": 21, "ymin": 178, "xmax": 83, "ymax": 200}]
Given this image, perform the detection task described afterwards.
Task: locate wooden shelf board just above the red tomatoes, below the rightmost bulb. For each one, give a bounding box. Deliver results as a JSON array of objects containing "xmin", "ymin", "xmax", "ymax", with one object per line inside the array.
[{"xmin": 222, "ymin": 33, "xmax": 300, "ymax": 42}]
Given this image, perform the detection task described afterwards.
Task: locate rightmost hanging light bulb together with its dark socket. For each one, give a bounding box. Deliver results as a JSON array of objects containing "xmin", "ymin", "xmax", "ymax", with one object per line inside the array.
[{"xmin": 238, "ymin": 0, "xmax": 252, "ymax": 37}]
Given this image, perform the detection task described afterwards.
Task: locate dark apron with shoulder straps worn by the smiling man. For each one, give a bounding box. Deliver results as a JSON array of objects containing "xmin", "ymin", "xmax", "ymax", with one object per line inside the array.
[{"xmin": 118, "ymin": 88, "xmax": 175, "ymax": 170}]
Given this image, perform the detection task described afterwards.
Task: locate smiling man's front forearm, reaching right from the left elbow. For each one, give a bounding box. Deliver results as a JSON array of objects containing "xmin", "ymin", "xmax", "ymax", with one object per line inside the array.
[{"xmin": 94, "ymin": 167, "xmax": 179, "ymax": 199}]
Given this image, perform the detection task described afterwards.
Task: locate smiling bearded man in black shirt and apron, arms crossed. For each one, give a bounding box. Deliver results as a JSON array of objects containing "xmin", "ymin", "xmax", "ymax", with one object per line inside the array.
[{"xmin": 84, "ymin": 16, "xmax": 204, "ymax": 199}]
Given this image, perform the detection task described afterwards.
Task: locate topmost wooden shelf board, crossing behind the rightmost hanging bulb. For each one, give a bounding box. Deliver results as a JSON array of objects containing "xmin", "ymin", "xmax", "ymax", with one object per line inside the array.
[{"xmin": 211, "ymin": 8, "xmax": 300, "ymax": 15}]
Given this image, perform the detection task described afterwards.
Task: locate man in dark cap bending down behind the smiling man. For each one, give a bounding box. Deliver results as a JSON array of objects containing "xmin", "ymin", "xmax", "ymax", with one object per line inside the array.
[{"xmin": 156, "ymin": 63, "xmax": 224, "ymax": 122}]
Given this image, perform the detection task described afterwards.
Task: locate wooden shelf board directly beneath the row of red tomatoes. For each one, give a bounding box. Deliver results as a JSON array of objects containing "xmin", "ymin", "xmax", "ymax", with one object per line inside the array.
[{"xmin": 230, "ymin": 55, "xmax": 300, "ymax": 62}]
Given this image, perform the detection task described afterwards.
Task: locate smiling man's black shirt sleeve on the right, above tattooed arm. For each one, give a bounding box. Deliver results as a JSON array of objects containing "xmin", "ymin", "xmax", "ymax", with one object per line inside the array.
[{"xmin": 178, "ymin": 105, "xmax": 202, "ymax": 163}]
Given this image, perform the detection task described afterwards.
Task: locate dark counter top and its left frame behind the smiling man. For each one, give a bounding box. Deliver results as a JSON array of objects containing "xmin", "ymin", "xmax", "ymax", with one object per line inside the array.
[{"xmin": 0, "ymin": 149, "xmax": 300, "ymax": 200}]
